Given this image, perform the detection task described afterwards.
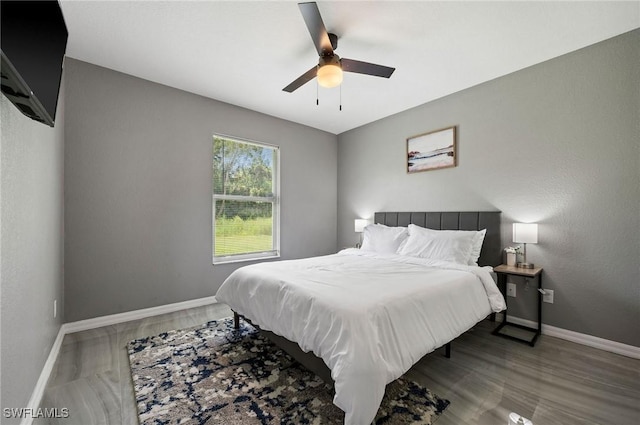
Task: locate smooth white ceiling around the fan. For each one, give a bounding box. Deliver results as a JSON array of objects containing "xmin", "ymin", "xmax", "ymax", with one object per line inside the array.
[{"xmin": 61, "ymin": 0, "xmax": 640, "ymax": 134}]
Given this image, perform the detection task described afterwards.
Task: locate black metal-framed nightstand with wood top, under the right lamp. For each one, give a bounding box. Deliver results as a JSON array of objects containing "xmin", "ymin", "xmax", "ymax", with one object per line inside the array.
[{"xmin": 493, "ymin": 264, "xmax": 542, "ymax": 347}]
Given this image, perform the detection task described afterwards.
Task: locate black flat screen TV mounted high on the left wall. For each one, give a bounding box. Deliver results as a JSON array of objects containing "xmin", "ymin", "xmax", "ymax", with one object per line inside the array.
[{"xmin": 0, "ymin": 0, "xmax": 68, "ymax": 127}]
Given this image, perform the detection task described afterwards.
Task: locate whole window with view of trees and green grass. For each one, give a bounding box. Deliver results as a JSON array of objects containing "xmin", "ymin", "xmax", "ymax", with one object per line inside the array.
[{"xmin": 213, "ymin": 135, "xmax": 280, "ymax": 263}]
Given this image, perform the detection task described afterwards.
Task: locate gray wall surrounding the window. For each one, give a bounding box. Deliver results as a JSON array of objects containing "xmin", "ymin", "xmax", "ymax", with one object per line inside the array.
[{"xmin": 65, "ymin": 60, "xmax": 337, "ymax": 321}]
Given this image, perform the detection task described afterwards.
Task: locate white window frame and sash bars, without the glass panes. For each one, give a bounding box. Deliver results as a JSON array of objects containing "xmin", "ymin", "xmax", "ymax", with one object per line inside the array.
[{"xmin": 211, "ymin": 133, "xmax": 280, "ymax": 265}]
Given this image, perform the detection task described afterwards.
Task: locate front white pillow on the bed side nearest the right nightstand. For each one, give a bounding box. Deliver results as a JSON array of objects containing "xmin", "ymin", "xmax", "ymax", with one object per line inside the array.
[{"xmin": 398, "ymin": 224, "xmax": 476, "ymax": 265}]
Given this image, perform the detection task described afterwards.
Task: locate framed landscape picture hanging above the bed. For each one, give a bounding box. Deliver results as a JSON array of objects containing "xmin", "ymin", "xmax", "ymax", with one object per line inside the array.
[{"xmin": 407, "ymin": 126, "xmax": 457, "ymax": 174}]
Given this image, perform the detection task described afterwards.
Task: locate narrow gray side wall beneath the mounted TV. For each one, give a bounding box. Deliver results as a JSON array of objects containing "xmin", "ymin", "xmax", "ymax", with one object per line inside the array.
[{"xmin": 0, "ymin": 81, "xmax": 64, "ymax": 416}]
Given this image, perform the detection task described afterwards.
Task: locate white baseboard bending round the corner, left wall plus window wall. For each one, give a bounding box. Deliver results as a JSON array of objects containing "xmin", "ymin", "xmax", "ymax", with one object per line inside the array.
[{"xmin": 20, "ymin": 297, "xmax": 217, "ymax": 425}]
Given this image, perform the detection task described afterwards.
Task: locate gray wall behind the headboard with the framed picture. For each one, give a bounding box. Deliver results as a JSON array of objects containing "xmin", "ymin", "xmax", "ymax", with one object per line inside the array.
[{"xmin": 338, "ymin": 30, "xmax": 640, "ymax": 346}]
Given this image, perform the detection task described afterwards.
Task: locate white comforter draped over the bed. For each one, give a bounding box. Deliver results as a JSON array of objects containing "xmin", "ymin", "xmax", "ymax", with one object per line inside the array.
[{"xmin": 216, "ymin": 249, "xmax": 505, "ymax": 425}]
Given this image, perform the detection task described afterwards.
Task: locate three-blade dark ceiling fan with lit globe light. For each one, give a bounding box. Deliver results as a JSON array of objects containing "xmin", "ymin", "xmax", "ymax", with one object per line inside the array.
[{"xmin": 282, "ymin": 2, "xmax": 395, "ymax": 93}]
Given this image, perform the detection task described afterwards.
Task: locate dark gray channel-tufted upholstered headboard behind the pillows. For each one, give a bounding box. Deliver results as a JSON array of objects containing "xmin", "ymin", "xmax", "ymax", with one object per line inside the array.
[{"xmin": 374, "ymin": 211, "xmax": 502, "ymax": 266}]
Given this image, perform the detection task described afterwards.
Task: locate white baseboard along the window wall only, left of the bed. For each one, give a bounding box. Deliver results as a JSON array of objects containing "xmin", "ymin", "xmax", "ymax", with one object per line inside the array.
[{"xmin": 62, "ymin": 297, "xmax": 217, "ymax": 333}]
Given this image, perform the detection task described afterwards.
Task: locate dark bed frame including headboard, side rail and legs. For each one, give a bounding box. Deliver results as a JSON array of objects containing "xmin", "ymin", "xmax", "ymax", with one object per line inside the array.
[{"xmin": 233, "ymin": 211, "xmax": 502, "ymax": 385}]
